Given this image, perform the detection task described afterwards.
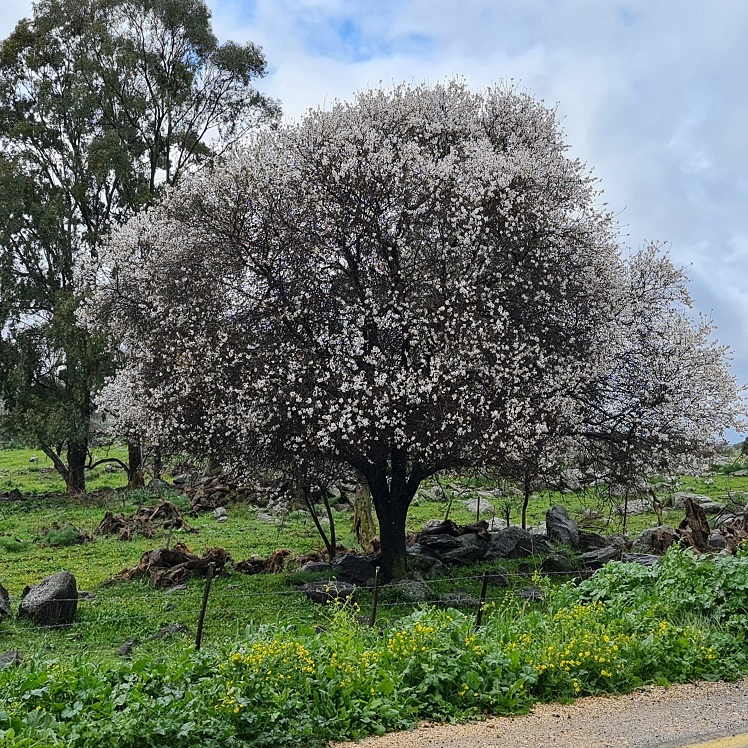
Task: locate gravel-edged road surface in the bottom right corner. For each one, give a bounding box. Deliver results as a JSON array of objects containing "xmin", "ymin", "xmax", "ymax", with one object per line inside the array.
[{"xmin": 332, "ymin": 679, "xmax": 748, "ymax": 748}]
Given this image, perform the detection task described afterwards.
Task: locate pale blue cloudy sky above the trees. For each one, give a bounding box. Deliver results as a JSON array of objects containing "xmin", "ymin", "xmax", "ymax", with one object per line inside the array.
[{"xmin": 0, "ymin": 0, "xmax": 748, "ymax": 426}]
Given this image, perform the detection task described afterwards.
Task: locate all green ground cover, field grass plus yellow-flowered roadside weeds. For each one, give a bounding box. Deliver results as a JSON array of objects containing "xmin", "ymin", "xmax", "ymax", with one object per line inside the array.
[{"xmin": 0, "ymin": 450, "xmax": 748, "ymax": 748}]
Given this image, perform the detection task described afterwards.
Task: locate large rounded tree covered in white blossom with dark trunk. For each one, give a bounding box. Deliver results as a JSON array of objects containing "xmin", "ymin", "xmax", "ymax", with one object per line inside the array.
[{"xmin": 88, "ymin": 82, "xmax": 744, "ymax": 578}]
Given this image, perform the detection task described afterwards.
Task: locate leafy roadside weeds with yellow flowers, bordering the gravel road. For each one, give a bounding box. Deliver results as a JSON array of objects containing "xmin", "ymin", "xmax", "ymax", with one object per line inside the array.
[{"xmin": 0, "ymin": 551, "xmax": 748, "ymax": 748}]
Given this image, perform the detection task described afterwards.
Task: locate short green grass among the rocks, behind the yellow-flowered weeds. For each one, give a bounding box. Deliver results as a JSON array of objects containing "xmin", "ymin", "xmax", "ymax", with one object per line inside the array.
[{"xmin": 0, "ymin": 449, "xmax": 748, "ymax": 658}]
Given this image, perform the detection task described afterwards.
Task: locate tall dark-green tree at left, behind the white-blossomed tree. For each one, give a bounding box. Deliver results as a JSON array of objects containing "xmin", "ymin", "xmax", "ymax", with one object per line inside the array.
[{"xmin": 0, "ymin": 0, "xmax": 278, "ymax": 492}]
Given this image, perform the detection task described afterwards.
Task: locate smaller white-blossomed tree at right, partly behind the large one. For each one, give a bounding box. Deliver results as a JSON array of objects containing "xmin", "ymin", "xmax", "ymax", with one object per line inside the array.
[{"xmin": 580, "ymin": 245, "xmax": 745, "ymax": 500}]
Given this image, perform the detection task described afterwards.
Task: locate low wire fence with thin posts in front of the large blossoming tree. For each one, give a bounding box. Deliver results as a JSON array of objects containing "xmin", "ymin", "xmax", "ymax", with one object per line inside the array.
[{"xmin": 0, "ymin": 568, "xmax": 592, "ymax": 653}]
